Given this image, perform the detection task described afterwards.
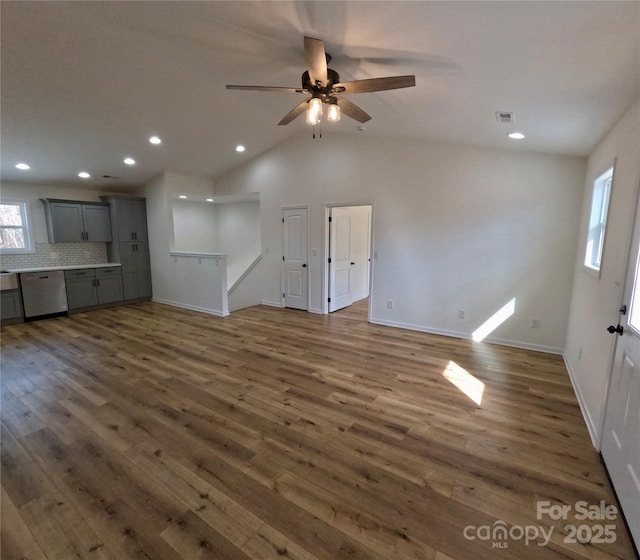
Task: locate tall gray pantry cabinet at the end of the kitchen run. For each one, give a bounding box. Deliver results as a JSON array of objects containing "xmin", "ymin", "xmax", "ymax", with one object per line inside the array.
[{"xmin": 100, "ymin": 196, "xmax": 151, "ymax": 300}]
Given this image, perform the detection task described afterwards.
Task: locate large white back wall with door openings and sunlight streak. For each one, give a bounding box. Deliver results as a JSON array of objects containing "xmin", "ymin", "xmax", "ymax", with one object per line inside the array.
[{"xmin": 215, "ymin": 132, "xmax": 586, "ymax": 352}]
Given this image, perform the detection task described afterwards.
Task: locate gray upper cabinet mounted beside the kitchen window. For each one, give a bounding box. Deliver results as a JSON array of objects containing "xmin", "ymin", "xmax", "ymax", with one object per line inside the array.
[{"xmin": 42, "ymin": 198, "xmax": 111, "ymax": 243}]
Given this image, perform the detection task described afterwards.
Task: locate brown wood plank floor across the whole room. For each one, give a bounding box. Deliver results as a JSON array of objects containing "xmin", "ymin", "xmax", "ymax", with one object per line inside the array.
[{"xmin": 1, "ymin": 302, "xmax": 633, "ymax": 560}]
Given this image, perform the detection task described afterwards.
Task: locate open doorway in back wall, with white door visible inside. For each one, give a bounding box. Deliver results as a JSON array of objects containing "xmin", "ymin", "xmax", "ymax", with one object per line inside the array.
[{"xmin": 323, "ymin": 204, "xmax": 373, "ymax": 321}]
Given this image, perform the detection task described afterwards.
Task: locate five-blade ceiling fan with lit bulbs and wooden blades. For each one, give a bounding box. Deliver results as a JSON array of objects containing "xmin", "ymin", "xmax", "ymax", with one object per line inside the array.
[{"xmin": 227, "ymin": 37, "xmax": 416, "ymax": 125}]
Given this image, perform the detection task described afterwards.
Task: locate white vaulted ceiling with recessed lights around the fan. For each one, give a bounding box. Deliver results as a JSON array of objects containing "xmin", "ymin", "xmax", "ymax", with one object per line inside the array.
[{"xmin": 1, "ymin": 1, "xmax": 640, "ymax": 187}]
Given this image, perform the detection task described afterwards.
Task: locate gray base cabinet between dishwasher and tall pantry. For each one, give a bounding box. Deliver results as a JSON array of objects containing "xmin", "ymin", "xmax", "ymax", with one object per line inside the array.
[{"xmin": 64, "ymin": 267, "xmax": 124, "ymax": 311}]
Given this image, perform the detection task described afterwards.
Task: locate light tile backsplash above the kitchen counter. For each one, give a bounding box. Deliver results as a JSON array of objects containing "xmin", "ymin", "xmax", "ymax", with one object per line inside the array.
[{"xmin": 0, "ymin": 241, "xmax": 108, "ymax": 270}]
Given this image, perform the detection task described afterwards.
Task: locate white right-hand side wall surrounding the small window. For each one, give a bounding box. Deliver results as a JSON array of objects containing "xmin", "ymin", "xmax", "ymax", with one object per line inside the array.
[{"xmin": 565, "ymin": 100, "xmax": 640, "ymax": 447}]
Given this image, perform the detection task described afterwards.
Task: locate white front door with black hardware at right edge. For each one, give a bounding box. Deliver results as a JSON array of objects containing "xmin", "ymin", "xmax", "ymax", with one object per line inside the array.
[{"xmin": 600, "ymin": 197, "xmax": 640, "ymax": 548}]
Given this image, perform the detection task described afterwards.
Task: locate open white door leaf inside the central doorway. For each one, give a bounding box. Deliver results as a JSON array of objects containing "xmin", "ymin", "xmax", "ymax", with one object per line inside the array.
[{"xmin": 329, "ymin": 207, "xmax": 353, "ymax": 312}]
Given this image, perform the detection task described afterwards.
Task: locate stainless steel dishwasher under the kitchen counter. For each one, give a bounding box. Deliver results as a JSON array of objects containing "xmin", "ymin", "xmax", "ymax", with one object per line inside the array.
[{"xmin": 20, "ymin": 270, "xmax": 68, "ymax": 318}]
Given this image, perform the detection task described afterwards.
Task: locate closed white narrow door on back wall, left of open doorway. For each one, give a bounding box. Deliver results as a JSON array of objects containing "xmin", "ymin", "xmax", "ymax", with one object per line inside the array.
[{"xmin": 282, "ymin": 208, "xmax": 309, "ymax": 310}]
